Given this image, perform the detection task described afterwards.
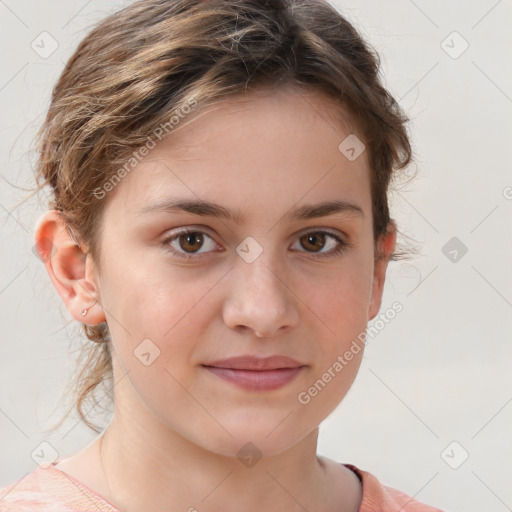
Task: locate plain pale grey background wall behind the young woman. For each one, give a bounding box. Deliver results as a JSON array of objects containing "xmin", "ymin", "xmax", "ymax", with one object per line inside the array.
[{"xmin": 0, "ymin": 0, "xmax": 512, "ymax": 512}]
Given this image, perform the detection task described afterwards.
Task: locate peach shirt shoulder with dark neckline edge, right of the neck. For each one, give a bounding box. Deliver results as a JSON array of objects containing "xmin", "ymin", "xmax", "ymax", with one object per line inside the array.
[{"xmin": 343, "ymin": 464, "xmax": 443, "ymax": 512}]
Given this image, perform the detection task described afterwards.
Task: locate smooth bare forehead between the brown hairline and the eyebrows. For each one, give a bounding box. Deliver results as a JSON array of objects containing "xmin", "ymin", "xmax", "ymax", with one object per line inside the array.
[{"xmin": 102, "ymin": 88, "xmax": 370, "ymax": 222}]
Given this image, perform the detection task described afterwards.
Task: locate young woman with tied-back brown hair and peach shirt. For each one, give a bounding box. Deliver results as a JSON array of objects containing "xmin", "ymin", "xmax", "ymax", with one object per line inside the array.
[{"xmin": 0, "ymin": 0, "xmax": 437, "ymax": 512}]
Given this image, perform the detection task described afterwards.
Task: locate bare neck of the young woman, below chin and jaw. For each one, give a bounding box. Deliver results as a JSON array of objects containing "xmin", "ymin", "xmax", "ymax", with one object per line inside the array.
[{"xmin": 101, "ymin": 410, "xmax": 332, "ymax": 512}]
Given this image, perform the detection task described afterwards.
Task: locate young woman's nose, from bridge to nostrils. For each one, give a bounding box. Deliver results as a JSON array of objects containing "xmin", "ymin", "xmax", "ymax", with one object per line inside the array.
[{"xmin": 223, "ymin": 253, "xmax": 299, "ymax": 338}]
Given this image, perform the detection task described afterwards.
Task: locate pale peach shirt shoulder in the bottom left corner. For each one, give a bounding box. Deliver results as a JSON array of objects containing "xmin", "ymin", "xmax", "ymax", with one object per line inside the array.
[{"xmin": 0, "ymin": 464, "xmax": 119, "ymax": 512}]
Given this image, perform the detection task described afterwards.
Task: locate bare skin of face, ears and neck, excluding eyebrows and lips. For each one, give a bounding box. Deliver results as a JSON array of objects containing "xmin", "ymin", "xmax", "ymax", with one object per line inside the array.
[{"xmin": 35, "ymin": 87, "xmax": 396, "ymax": 512}]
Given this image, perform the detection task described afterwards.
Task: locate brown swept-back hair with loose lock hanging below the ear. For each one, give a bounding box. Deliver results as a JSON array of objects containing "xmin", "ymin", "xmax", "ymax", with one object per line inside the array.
[{"xmin": 36, "ymin": 0, "xmax": 411, "ymax": 432}]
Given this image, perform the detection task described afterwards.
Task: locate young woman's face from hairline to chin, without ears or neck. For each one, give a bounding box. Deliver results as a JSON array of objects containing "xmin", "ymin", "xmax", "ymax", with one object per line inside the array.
[{"xmin": 85, "ymin": 89, "xmax": 392, "ymax": 455}]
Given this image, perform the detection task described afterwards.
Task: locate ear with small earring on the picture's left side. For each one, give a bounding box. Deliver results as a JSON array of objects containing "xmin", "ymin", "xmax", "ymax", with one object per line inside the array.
[{"xmin": 34, "ymin": 210, "xmax": 106, "ymax": 325}]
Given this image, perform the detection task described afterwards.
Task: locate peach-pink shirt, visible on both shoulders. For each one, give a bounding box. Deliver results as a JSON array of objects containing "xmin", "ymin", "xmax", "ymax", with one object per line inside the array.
[{"xmin": 0, "ymin": 463, "xmax": 442, "ymax": 512}]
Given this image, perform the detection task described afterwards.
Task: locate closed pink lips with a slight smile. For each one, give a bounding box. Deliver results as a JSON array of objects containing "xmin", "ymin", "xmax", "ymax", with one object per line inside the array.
[{"xmin": 202, "ymin": 356, "xmax": 307, "ymax": 391}]
